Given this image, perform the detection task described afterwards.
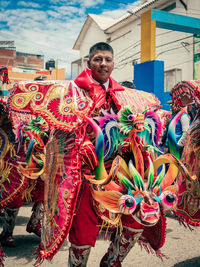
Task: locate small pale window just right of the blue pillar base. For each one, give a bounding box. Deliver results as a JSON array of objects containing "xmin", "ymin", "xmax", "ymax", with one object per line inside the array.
[{"xmin": 164, "ymin": 69, "xmax": 182, "ymax": 92}]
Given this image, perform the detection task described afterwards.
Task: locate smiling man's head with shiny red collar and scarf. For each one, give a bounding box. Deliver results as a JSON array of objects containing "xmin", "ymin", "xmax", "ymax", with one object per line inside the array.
[{"xmin": 75, "ymin": 42, "xmax": 124, "ymax": 112}]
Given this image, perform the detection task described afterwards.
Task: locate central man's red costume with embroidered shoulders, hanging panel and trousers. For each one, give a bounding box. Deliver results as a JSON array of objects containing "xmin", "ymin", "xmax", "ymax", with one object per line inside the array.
[{"xmin": 0, "ymin": 73, "xmax": 169, "ymax": 266}]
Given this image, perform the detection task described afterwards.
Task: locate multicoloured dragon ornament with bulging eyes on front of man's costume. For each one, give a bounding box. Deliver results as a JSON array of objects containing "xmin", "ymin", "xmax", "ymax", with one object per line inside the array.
[{"xmin": 85, "ymin": 108, "xmax": 193, "ymax": 257}]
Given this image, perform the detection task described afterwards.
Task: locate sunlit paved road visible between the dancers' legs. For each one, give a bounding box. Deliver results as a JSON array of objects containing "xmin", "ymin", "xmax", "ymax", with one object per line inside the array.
[{"xmin": 0, "ymin": 206, "xmax": 200, "ymax": 267}]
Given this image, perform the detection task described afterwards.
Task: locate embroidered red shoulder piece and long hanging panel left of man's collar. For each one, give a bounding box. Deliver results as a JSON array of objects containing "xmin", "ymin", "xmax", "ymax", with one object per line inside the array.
[{"xmin": 0, "ymin": 81, "xmax": 93, "ymax": 262}]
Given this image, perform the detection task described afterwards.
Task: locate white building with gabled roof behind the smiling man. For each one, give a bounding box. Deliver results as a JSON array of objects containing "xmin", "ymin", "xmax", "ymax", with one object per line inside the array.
[{"xmin": 71, "ymin": 0, "xmax": 200, "ymax": 110}]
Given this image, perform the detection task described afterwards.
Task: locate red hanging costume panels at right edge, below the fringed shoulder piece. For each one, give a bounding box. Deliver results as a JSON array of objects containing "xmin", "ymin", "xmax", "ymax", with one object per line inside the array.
[{"xmin": 176, "ymin": 110, "xmax": 200, "ymax": 226}]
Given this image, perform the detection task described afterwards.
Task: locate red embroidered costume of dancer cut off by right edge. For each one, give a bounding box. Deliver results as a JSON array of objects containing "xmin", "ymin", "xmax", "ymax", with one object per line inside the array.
[{"xmin": 171, "ymin": 80, "xmax": 200, "ymax": 226}]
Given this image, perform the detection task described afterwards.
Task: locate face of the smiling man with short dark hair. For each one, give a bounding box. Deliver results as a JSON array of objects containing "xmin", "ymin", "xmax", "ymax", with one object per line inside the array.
[{"xmin": 87, "ymin": 50, "xmax": 114, "ymax": 84}]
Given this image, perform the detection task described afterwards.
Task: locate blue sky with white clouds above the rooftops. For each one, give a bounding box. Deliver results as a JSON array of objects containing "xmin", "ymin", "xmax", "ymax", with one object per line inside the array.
[{"xmin": 0, "ymin": 0, "xmax": 141, "ymax": 77}]
